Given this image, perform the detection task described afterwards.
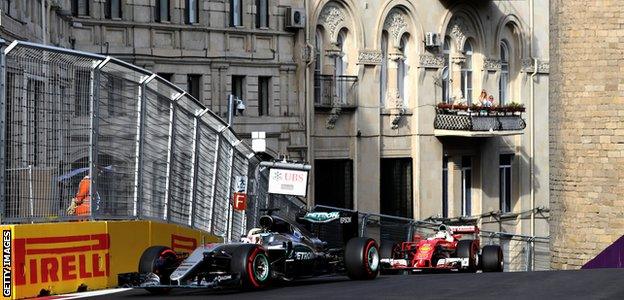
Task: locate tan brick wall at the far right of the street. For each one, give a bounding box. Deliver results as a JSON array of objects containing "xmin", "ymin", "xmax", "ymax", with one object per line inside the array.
[{"xmin": 550, "ymin": 0, "xmax": 624, "ymax": 269}]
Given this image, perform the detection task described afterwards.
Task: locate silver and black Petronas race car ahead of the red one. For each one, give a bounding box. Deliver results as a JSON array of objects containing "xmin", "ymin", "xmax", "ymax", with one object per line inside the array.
[{"xmin": 126, "ymin": 210, "xmax": 379, "ymax": 294}]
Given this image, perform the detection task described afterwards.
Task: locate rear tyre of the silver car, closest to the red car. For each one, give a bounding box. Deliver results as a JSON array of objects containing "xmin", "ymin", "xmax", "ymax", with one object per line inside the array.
[{"xmin": 344, "ymin": 237, "xmax": 379, "ymax": 280}]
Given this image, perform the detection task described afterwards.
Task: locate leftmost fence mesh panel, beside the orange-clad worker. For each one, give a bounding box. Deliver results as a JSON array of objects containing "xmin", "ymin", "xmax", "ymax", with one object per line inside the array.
[{"xmin": 2, "ymin": 48, "xmax": 97, "ymax": 222}]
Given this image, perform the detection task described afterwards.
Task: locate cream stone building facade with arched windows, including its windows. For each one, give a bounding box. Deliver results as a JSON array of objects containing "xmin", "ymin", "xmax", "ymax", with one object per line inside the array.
[{"xmin": 307, "ymin": 0, "xmax": 549, "ymax": 269}]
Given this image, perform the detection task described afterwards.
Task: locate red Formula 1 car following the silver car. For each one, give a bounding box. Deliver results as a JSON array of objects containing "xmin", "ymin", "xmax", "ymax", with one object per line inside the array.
[{"xmin": 380, "ymin": 225, "xmax": 503, "ymax": 273}]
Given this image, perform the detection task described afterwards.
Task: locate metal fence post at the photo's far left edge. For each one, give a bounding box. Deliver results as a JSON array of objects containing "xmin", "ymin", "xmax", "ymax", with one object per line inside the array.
[{"xmin": 0, "ymin": 39, "xmax": 8, "ymax": 223}]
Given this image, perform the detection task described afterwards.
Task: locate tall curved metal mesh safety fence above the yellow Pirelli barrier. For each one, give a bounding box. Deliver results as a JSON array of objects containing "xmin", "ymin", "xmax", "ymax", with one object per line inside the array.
[{"xmin": 0, "ymin": 41, "xmax": 252, "ymax": 238}]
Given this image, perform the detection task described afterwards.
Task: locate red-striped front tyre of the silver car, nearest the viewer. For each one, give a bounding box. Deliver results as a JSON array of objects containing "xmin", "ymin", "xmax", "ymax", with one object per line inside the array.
[{"xmin": 230, "ymin": 244, "xmax": 271, "ymax": 289}]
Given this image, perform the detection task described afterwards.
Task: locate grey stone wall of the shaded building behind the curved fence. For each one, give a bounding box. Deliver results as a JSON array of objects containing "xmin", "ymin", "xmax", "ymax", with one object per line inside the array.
[{"xmin": 0, "ymin": 0, "xmax": 307, "ymax": 160}]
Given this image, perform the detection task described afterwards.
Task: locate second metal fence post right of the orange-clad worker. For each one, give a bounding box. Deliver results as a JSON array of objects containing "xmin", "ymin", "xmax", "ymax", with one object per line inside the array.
[{"xmin": 133, "ymin": 74, "xmax": 156, "ymax": 217}]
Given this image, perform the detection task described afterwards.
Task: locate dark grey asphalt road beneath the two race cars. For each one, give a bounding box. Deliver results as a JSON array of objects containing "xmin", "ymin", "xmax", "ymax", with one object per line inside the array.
[{"xmin": 98, "ymin": 269, "xmax": 624, "ymax": 300}]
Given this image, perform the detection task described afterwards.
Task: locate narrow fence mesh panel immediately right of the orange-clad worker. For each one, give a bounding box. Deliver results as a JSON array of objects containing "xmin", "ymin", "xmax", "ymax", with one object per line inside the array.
[{"xmin": 92, "ymin": 69, "xmax": 140, "ymax": 218}]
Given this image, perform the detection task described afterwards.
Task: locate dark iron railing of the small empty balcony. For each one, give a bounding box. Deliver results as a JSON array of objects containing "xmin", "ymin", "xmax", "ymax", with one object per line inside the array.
[{"xmin": 314, "ymin": 74, "xmax": 358, "ymax": 108}]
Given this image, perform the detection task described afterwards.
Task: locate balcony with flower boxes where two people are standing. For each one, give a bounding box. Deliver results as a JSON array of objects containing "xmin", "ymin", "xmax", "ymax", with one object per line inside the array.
[{"xmin": 433, "ymin": 104, "xmax": 526, "ymax": 137}]
